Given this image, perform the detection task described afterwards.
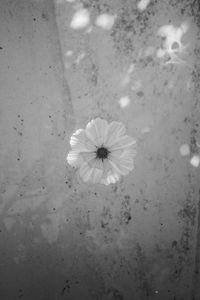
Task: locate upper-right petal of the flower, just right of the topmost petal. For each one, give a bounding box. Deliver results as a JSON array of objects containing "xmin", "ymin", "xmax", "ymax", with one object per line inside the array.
[{"xmin": 105, "ymin": 121, "xmax": 126, "ymax": 147}]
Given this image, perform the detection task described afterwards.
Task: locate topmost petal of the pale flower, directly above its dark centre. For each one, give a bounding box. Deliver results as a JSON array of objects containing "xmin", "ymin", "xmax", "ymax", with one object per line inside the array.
[{"xmin": 85, "ymin": 118, "xmax": 108, "ymax": 146}]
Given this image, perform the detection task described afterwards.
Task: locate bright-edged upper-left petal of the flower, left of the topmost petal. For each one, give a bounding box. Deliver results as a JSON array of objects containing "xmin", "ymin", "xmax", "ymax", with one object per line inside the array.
[{"xmin": 70, "ymin": 129, "xmax": 96, "ymax": 152}]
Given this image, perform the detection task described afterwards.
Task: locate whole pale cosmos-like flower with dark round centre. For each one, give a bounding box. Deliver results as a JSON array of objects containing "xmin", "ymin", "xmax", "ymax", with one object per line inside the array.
[{"xmin": 67, "ymin": 118, "xmax": 136, "ymax": 185}]
